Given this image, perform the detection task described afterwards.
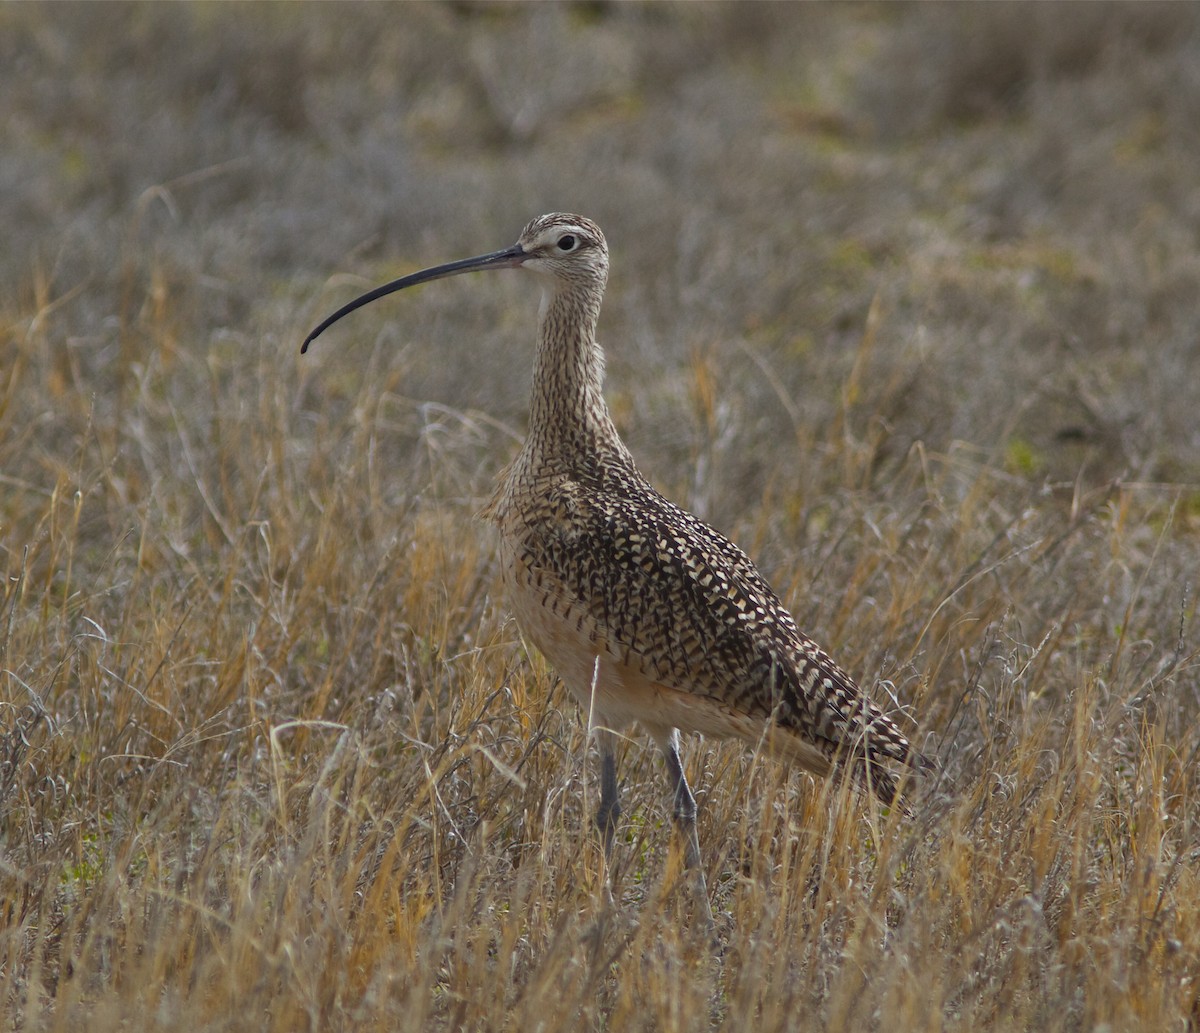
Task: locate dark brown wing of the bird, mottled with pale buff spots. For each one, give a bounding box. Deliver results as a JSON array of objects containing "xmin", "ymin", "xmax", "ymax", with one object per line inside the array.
[{"xmin": 524, "ymin": 480, "xmax": 923, "ymax": 797}]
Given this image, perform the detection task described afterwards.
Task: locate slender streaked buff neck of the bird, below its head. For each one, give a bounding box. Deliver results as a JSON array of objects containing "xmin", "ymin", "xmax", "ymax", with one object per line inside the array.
[{"xmin": 524, "ymin": 284, "xmax": 632, "ymax": 473}]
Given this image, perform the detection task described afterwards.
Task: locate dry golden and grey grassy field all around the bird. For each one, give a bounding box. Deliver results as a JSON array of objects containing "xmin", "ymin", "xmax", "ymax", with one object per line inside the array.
[{"xmin": 0, "ymin": 4, "xmax": 1200, "ymax": 1033}]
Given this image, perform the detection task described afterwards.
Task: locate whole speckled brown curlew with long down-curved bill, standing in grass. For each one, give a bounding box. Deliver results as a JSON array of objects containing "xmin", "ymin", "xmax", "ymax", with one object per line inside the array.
[{"xmin": 301, "ymin": 212, "xmax": 932, "ymax": 923}]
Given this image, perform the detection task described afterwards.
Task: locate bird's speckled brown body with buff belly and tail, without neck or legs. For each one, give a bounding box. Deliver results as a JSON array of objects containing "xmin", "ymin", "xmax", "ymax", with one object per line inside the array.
[{"xmin": 492, "ymin": 446, "xmax": 917, "ymax": 800}]
